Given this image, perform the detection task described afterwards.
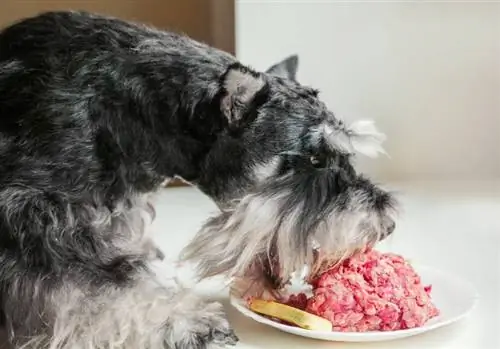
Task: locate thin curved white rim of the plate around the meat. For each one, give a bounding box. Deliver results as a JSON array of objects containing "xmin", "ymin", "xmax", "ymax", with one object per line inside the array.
[{"xmin": 229, "ymin": 263, "xmax": 480, "ymax": 341}]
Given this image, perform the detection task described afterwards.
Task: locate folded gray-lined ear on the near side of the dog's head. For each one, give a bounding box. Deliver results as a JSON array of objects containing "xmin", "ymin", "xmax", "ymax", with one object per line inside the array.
[{"xmin": 221, "ymin": 64, "xmax": 267, "ymax": 128}]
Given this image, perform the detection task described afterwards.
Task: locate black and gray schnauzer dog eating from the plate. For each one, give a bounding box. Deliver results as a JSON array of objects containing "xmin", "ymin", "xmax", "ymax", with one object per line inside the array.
[{"xmin": 0, "ymin": 11, "xmax": 395, "ymax": 349}]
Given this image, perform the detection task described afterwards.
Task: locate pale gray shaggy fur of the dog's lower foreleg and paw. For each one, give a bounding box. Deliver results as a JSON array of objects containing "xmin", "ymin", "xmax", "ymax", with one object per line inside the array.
[{"xmin": 18, "ymin": 277, "xmax": 237, "ymax": 349}]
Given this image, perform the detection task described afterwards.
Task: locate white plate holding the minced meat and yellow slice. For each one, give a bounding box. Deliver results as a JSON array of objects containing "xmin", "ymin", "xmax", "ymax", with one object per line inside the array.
[{"xmin": 231, "ymin": 267, "xmax": 478, "ymax": 342}]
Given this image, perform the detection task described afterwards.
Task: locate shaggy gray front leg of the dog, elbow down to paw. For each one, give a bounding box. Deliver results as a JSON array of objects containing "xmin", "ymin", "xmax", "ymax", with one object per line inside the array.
[{"xmin": 0, "ymin": 196, "xmax": 237, "ymax": 349}]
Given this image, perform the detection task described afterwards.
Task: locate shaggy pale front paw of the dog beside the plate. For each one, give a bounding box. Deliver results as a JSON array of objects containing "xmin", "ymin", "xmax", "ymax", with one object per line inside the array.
[{"xmin": 169, "ymin": 302, "xmax": 238, "ymax": 349}]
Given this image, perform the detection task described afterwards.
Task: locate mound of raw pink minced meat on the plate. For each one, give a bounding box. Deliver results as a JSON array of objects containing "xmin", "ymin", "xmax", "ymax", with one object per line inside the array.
[{"xmin": 286, "ymin": 250, "xmax": 439, "ymax": 332}]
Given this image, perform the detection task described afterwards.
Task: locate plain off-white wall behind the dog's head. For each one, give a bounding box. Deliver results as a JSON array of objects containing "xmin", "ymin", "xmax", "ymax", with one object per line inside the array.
[{"xmin": 236, "ymin": 0, "xmax": 500, "ymax": 180}]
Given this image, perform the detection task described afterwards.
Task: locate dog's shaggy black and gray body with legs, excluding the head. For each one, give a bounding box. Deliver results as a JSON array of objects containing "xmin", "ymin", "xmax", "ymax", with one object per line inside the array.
[{"xmin": 0, "ymin": 12, "xmax": 244, "ymax": 349}]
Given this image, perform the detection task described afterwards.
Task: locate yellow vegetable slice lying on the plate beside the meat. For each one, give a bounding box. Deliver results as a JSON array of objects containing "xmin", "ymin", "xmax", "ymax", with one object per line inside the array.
[{"xmin": 249, "ymin": 299, "xmax": 332, "ymax": 331}]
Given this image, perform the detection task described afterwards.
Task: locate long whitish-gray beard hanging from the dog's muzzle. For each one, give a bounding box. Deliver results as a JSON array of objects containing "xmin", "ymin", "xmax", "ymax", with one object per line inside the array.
[{"xmin": 184, "ymin": 177, "xmax": 396, "ymax": 292}]
